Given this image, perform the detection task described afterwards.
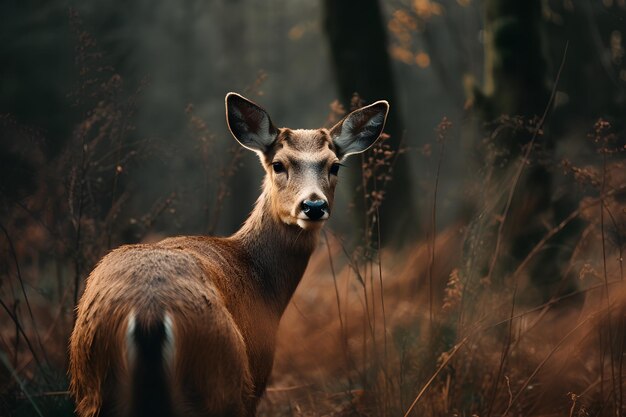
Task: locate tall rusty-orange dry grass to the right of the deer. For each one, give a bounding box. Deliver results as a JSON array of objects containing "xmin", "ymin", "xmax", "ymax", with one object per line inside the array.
[{"xmin": 255, "ymin": 115, "xmax": 626, "ymax": 416}]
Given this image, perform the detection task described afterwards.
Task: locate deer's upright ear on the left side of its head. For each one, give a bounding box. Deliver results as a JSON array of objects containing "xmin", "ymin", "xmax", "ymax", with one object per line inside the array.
[{"xmin": 226, "ymin": 93, "xmax": 278, "ymax": 153}]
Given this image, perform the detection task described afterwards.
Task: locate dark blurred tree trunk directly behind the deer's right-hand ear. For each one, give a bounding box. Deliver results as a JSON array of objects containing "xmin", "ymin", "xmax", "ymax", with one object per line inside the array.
[{"xmin": 324, "ymin": 0, "xmax": 419, "ymax": 246}]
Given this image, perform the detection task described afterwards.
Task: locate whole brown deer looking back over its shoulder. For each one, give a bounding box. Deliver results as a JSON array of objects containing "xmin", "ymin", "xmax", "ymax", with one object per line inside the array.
[{"xmin": 69, "ymin": 93, "xmax": 389, "ymax": 417}]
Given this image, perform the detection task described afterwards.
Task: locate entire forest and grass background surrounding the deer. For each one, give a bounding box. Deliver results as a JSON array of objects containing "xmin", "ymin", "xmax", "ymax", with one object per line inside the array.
[{"xmin": 0, "ymin": 0, "xmax": 626, "ymax": 416}]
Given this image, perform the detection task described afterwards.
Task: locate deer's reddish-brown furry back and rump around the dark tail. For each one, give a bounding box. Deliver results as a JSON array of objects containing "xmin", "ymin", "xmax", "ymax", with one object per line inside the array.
[{"xmin": 70, "ymin": 238, "xmax": 273, "ymax": 416}]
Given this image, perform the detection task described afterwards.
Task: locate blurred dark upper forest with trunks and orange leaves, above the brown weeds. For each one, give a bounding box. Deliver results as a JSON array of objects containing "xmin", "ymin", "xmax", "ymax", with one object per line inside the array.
[{"xmin": 0, "ymin": 0, "xmax": 626, "ymax": 237}]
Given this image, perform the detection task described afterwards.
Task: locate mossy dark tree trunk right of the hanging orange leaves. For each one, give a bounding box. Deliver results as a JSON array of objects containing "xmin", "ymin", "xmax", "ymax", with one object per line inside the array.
[{"xmin": 474, "ymin": 0, "xmax": 580, "ymax": 301}]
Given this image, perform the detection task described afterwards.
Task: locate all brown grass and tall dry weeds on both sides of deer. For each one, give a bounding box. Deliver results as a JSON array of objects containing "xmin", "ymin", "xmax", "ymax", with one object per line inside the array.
[{"xmin": 0, "ymin": 6, "xmax": 626, "ymax": 417}]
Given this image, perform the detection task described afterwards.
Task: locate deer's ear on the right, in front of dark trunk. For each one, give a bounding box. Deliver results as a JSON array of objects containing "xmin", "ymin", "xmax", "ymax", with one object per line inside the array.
[{"xmin": 330, "ymin": 100, "xmax": 389, "ymax": 159}]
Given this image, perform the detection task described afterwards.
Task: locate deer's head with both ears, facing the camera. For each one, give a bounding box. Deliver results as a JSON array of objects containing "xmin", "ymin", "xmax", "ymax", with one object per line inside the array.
[{"xmin": 226, "ymin": 93, "xmax": 389, "ymax": 230}]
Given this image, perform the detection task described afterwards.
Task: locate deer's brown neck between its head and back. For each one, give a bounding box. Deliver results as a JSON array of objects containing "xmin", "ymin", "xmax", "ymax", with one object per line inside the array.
[{"xmin": 232, "ymin": 183, "xmax": 319, "ymax": 314}]
